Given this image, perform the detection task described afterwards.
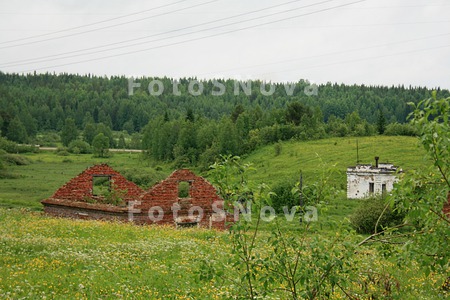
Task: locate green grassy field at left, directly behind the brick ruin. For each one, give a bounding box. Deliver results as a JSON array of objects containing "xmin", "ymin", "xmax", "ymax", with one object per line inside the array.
[{"xmin": 0, "ymin": 151, "xmax": 172, "ymax": 210}]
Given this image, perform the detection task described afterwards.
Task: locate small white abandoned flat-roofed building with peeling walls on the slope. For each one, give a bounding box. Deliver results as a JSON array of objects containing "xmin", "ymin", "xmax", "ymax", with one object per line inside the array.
[{"xmin": 347, "ymin": 157, "xmax": 402, "ymax": 199}]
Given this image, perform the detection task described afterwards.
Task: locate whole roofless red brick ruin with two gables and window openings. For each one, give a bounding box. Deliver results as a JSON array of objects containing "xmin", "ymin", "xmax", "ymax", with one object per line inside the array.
[{"xmin": 42, "ymin": 164, "xmax": 233, "ymax": 229}]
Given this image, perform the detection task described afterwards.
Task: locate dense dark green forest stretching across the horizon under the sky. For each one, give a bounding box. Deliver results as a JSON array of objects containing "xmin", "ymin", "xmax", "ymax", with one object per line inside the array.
[{"xmin": 0, "ymin": 72, "xmax": 450, "ymax": 165}]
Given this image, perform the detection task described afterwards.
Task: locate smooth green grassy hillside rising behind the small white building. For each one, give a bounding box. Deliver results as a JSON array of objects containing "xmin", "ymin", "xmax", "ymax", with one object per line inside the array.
[{"xmin": 246, "ymin": 136, "xmax": 428, "ymax": 189}]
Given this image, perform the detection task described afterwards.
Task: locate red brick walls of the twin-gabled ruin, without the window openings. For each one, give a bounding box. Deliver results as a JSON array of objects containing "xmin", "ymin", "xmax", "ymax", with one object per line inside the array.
[{"xmin": 42, "ymin": 164, "xmax": 233, "ymax": 229}]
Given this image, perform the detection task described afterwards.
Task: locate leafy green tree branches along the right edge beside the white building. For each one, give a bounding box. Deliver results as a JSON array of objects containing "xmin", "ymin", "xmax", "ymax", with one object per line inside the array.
[{"xmin": 389, "ymin": 93, "xmax": 450, "ymax": 282}]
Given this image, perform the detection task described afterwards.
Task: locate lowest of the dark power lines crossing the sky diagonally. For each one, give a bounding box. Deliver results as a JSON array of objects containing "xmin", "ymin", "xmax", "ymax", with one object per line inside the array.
[{"xmin": 21, "ymin": 0, "xmax": 368, "ymax": 73}]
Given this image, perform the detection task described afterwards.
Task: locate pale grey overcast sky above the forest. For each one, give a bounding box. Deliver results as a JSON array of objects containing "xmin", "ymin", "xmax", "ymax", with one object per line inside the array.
[{"xmin": 0, "ymin": 0, "xmax": 450, "ymax": 89}]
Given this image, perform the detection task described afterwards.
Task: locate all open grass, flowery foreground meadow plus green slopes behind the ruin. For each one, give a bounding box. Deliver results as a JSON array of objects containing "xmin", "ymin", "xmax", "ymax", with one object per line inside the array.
[{"xmin": 0, "ymin": 137, "xmax": 445, "ymax": 299}]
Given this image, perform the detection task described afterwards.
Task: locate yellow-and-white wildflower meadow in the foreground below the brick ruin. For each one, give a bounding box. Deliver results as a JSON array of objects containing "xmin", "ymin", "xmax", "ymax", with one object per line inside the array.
[{"xmin": 0, "ymin": 209, "xmax": 445, "ymax": 299}]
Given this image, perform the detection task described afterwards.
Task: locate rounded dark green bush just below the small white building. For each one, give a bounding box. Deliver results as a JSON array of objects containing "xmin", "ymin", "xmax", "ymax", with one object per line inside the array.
[{"xmin": 350, "ymin": 197, "xmax": 403, "ymax": 234}]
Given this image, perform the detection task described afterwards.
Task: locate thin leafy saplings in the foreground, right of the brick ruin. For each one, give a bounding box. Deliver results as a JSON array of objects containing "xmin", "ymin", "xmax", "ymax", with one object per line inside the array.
[{"xmin": 207, "ymin": 156, "xmax": 446, "ymax": 299}]
